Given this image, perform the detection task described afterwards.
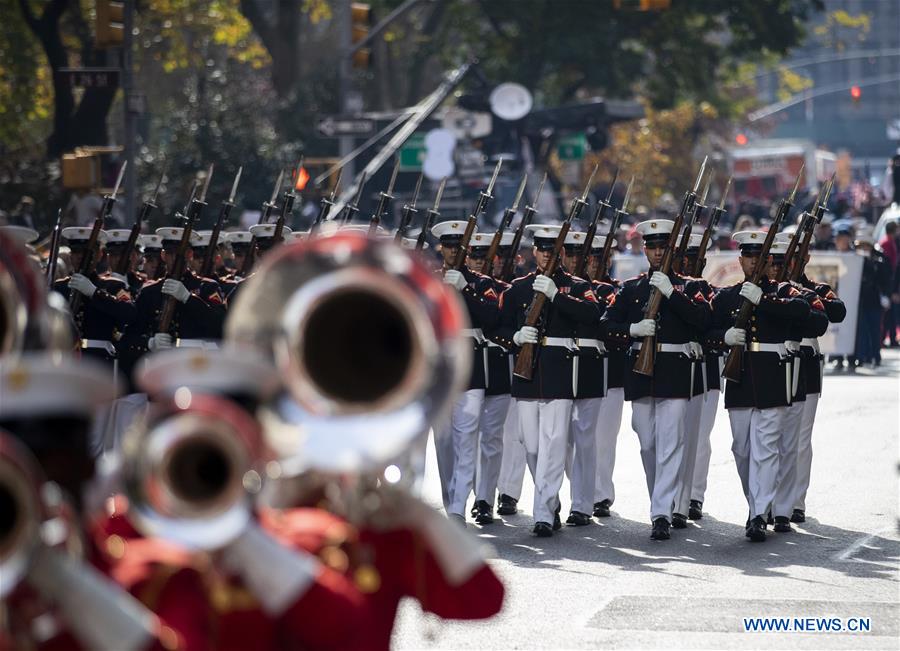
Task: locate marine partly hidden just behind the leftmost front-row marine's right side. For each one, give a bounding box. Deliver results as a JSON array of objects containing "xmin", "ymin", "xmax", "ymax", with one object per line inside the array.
[{"xmin": 466, "ymin": 233, "xmax": 512, "ymax": 525}]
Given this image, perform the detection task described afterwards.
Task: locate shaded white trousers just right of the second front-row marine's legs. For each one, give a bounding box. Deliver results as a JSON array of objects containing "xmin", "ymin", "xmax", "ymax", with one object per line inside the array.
[{"xmin": 566, "ymin": 398, "xmax": 603, "ymax": 515}]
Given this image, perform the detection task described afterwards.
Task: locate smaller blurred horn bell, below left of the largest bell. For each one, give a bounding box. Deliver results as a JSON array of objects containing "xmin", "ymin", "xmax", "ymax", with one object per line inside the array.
[{"xmin": 122, "ymin": 388, "xmax": 264, "ymax": 549}]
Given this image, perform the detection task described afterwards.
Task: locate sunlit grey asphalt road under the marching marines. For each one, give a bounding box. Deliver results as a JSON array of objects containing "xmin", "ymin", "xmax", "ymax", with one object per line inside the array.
[{"xmin": 394, "ymin": 352, "xmax": 900, "ymax": 649}]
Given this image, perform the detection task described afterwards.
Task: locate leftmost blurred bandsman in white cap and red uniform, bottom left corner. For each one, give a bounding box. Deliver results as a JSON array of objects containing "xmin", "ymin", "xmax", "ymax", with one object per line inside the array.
[{"xmin": 0, "ymin": 352, "xmax": 212, "ymax": 651}]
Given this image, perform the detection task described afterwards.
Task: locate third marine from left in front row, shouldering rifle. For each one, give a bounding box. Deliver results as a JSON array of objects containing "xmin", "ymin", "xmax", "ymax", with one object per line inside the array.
[{"xmin": 601, "ymin": 219, "xmax": 711, "ymax": 540}]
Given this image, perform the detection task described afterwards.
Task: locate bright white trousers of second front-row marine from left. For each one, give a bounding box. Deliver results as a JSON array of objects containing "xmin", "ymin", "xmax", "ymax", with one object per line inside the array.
[{"xmin": 518, "ymin": 399, "xmax": 573, "ymax": 524}]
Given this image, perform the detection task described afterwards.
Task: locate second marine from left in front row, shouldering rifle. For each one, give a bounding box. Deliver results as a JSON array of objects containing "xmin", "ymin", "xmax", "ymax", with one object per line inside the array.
[{"xmin": 495, "ymin": 224, "xmax": 600, "ymax": 537}]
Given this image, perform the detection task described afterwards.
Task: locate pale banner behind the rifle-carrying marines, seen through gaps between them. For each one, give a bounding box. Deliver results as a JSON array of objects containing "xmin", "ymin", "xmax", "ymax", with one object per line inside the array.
[{"xmin": 612, "ymin": 251, "xmax": 863, "ymax": 355}]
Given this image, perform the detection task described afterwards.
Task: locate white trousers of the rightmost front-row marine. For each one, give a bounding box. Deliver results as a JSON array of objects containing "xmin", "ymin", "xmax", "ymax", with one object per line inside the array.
[{"xmin": 728, "ymin": 407, "xmax": 787, "ymax": 517}]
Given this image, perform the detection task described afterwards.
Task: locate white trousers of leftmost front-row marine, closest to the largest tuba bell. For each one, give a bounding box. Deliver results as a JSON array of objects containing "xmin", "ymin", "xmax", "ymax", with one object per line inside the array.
[{"xmin": 434, "ymin": 389, "xmax": 484, "ymax": 515}]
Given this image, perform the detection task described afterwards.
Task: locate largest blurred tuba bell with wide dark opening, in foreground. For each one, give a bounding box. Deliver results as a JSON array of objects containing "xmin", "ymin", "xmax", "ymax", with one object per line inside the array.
[{"xmin": 225, "ymin": 231, "xmax": 471, "ymax": 483}]
